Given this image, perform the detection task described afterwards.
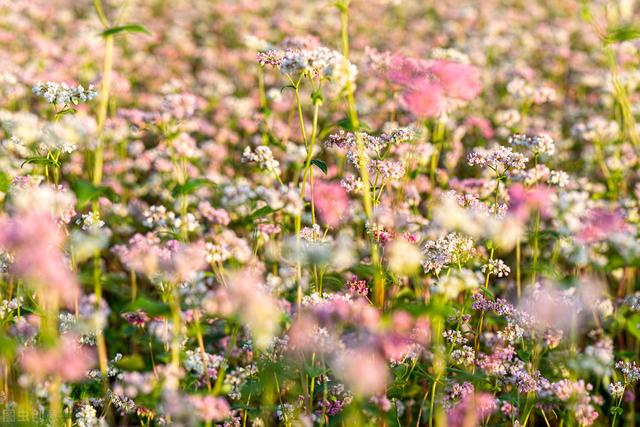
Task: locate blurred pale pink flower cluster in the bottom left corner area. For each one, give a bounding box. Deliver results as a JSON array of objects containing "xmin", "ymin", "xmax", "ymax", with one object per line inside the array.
[{"xmin": 20, "ymin": 334, "xmax": 95, "ymax": 382}]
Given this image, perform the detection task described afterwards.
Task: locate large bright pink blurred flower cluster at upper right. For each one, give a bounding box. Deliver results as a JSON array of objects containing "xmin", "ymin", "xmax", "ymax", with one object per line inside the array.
[{"xmin": 389, "ymin": 56, "xmax": 482, "ymax": 117}]
